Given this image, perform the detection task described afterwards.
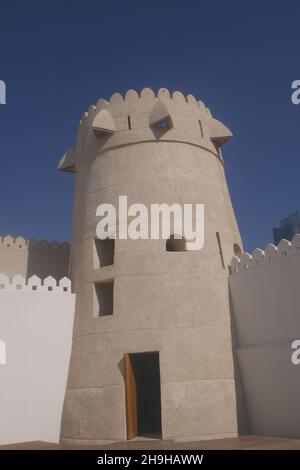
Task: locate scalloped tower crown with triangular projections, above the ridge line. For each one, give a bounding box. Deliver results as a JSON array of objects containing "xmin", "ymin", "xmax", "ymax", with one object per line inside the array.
[{"xmin": 59, "ymin": 88, "xmax": 232, "ymax": 172}]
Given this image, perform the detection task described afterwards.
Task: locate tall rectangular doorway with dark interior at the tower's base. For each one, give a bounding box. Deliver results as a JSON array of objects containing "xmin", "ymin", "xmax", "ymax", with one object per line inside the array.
[{"xmin": 124, "ymin": 352, "xmax": 161, "ymax": 439}]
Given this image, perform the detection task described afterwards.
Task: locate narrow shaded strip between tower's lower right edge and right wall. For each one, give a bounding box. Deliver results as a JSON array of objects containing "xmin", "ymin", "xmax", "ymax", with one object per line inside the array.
[{"xmin": 228, "ymin": 286, "xmax": 251, "ymax": 435}]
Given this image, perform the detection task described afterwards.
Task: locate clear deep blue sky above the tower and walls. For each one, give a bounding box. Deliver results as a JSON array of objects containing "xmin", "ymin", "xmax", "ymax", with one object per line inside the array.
[{"xmin": 0, "ymin": 0, "xmax": 300, "ymax": 250}]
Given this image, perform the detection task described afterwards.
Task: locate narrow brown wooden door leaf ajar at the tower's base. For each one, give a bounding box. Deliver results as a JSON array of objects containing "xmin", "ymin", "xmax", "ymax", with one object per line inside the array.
[{"xmin": 124, "ymin": 354, "xmax": 138, "ymax": 439}]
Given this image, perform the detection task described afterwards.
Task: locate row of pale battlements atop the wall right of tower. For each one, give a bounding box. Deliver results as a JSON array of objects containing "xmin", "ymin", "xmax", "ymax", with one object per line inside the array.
[{"xmin": 230, "ymin": 233, "xmax": 300, "ymax": 275}]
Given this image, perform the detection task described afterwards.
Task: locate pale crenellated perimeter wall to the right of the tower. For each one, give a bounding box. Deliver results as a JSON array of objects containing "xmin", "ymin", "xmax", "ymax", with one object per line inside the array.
[{"xmin": 230, "ymin": 235, "xmax": 300, "ymax": 438}]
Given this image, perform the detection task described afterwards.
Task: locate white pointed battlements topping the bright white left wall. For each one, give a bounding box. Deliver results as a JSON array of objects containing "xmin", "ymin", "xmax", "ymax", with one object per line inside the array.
[{"xmin": 0, "ymin": 273, "xmax": 71, "ymax": 293}]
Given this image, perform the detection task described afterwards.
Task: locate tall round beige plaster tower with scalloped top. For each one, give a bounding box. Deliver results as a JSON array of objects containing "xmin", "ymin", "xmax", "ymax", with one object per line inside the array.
[{"xmin": 59, "ymin": 88, "xmax": 241, "ymax": 442}]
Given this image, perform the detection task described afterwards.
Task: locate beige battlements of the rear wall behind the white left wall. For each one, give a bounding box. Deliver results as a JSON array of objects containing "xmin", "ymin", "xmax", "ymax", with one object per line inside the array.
[{"xmin": 0, "ymin": 235, "xmax": 70, "ymax": 253}]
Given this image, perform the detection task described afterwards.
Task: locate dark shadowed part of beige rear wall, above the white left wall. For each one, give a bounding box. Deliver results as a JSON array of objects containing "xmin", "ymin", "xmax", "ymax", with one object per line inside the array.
[{"xmin": 26, "ymin": 240, "xmax": 69, "ymax": 279}]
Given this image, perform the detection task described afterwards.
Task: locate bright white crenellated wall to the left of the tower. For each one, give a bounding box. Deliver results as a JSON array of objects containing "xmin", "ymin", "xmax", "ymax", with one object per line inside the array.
[{"xmin": 0, "ymin": 279, "xmax": 75, "ymax": 444}]
